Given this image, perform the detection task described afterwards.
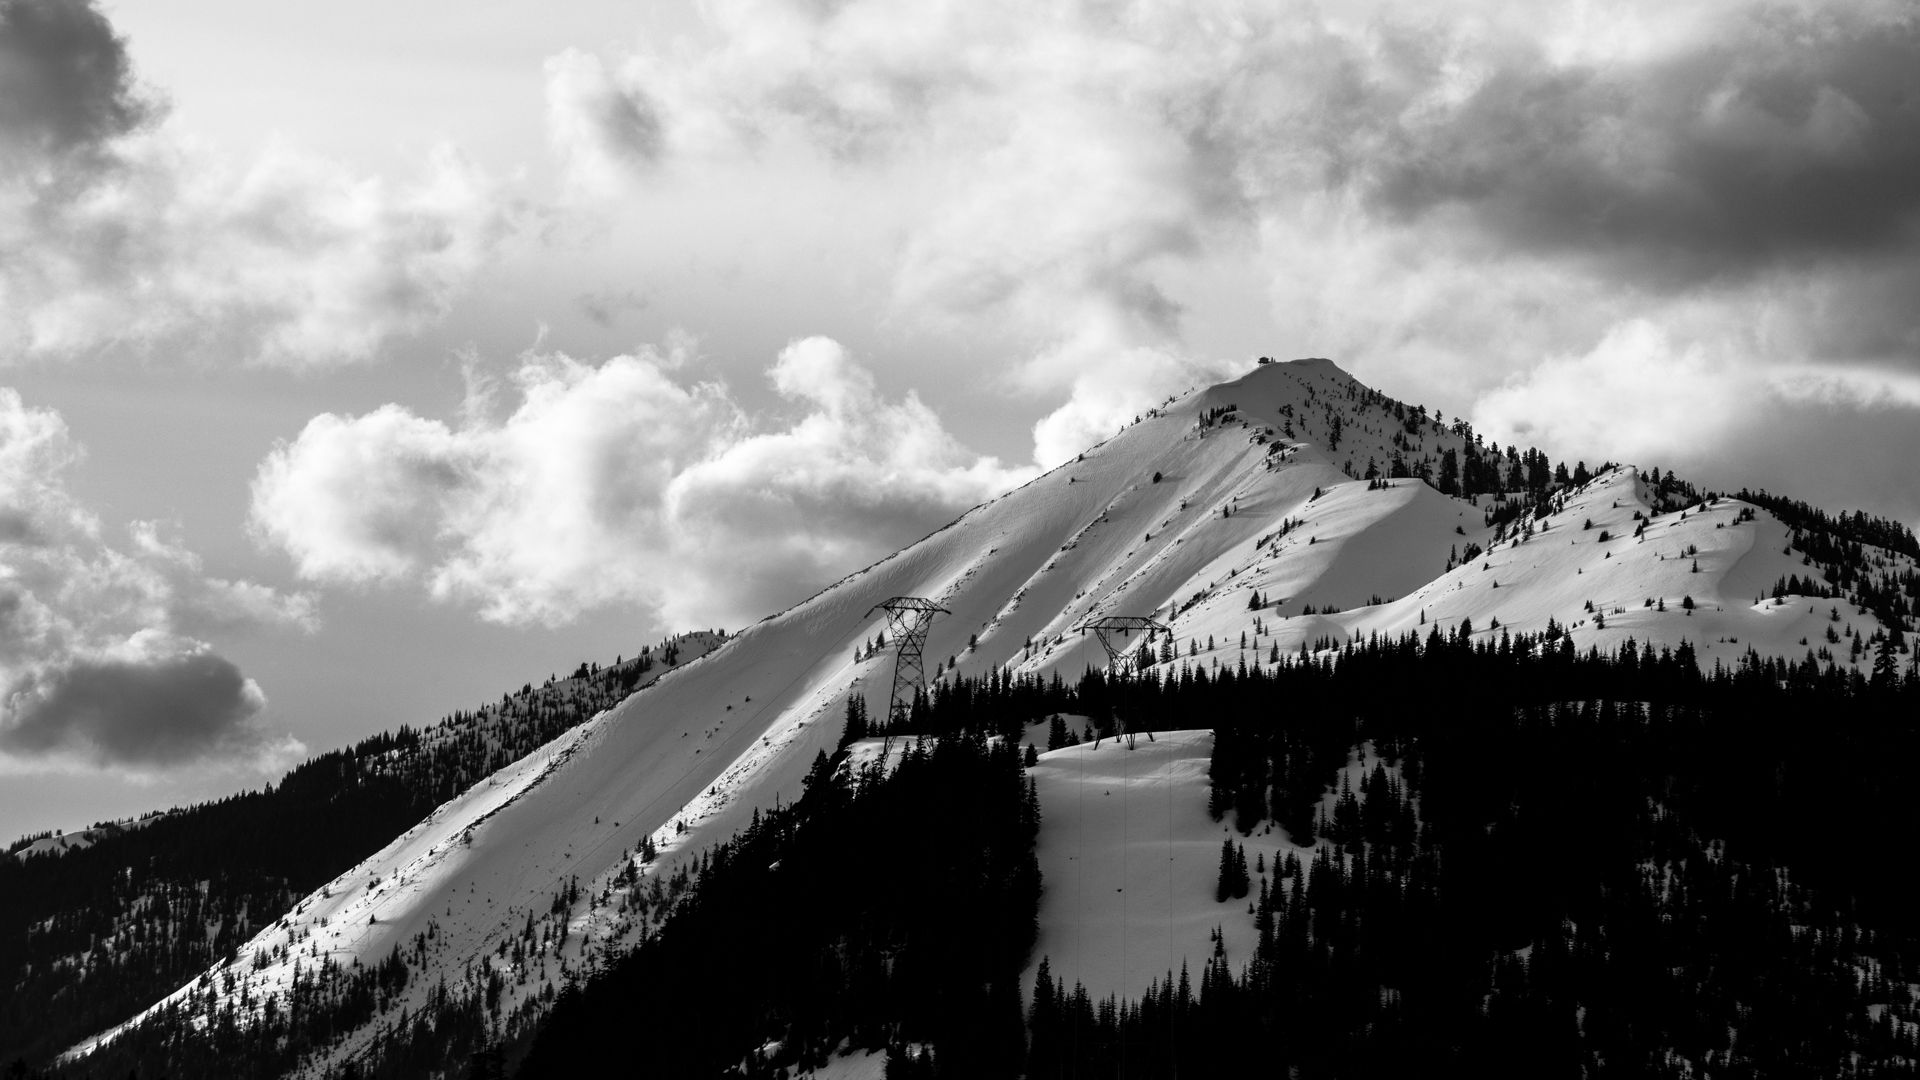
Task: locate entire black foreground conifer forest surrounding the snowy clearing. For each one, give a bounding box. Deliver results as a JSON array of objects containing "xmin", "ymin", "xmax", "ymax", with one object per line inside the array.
[{"xmin": 18, "ymin": 626, "xmax": 1920, "ymax": 1078}]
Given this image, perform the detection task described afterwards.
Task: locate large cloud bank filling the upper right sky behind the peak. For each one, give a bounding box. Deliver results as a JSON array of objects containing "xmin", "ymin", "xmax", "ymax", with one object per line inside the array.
[{"xmin": 549, "ymin": 0, "xmax": 1920, "ymax": 513}]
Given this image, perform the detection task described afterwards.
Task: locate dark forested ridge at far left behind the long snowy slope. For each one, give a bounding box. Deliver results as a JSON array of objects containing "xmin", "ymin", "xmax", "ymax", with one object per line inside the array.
[{"xmin": 0, "ymin": 642, "xmax": 706, "ymax": 1065}]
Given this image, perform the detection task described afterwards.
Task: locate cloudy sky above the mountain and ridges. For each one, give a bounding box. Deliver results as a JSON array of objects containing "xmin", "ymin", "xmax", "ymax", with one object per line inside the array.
[{"xmin": 0, "ymin": 0, "xmax": 1920, "ymax": 838}]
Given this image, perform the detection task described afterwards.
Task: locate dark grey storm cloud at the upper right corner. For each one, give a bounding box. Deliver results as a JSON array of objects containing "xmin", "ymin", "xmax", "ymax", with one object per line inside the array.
[{"xmin": 1367, "ymin": 4, "xmax": 1920, "ymax": 286}]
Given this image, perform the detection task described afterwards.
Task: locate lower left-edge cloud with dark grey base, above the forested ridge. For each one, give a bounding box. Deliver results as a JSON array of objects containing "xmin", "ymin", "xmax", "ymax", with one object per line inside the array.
[{"xmin": 0, "ymin": 388, "xmax": 313, "ymax": 773}]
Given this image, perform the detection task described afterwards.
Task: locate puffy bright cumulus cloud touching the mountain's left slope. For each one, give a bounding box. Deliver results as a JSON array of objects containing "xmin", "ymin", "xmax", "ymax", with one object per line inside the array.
[{"xmin": 252, "ymin": 338, "xmax": 1027, "ymax": 625}]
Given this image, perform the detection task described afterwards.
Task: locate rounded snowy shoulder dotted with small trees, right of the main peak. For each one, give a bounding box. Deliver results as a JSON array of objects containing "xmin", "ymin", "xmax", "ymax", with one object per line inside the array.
[{"xmin": 1152, "ymin": 469, "xmax": 1897, "ymax": 671}]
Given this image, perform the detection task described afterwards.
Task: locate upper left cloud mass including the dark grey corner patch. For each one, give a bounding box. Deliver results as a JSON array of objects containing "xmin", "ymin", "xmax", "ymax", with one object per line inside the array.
[{"xmin": 0, "ymin": 0, "xmax": 511, "ymax": 367}]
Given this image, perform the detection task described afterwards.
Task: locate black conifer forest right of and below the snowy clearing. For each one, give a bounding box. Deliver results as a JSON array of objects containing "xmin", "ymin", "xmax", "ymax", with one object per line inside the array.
[{"xmin": 1031, "ymin": 638, "xmax": 1920, "ymax": 1078}]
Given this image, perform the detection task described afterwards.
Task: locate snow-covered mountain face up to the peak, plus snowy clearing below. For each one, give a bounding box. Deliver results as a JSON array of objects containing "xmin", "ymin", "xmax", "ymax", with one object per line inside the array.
[{"xmin": 45, "ymin": 359, "xmax": 1920, "ymax": 1074}]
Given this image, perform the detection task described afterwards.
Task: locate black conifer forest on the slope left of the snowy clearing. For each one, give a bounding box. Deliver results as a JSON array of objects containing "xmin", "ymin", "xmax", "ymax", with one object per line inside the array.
[{"xmin": 518, "ymin": 732, "xmax": 1041, "ymax": 1078}]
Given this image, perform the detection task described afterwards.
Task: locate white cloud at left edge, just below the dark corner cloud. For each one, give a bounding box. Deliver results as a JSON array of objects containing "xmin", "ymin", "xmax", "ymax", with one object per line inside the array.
[{"xmin": 0, "ymin": 131, "xmax": 505, "ymax": 367}]
